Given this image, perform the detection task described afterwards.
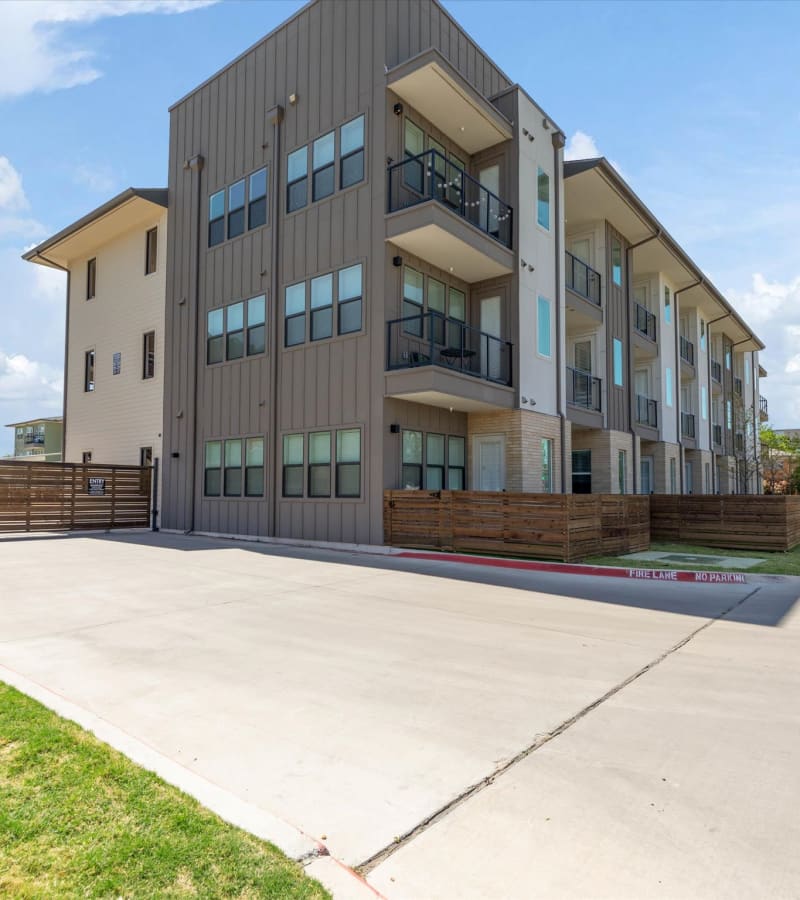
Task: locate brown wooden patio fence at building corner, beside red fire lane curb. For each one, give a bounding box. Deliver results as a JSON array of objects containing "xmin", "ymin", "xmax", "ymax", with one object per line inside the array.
[{"xmin": 383, "ymin": 490, "xmax": 650, "ymax": 562}]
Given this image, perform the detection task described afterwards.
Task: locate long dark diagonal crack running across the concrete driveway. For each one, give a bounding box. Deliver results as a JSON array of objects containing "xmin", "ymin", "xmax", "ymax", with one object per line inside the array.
[{"xmin": 353, "ymin": 585, "xmax": 761, "ymax": 876}]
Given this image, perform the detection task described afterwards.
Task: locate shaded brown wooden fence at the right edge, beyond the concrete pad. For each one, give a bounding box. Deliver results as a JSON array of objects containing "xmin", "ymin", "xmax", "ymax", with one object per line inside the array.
[{"xmin": 650, "ymin": 494, "xmax": 800, "ymax": 551}]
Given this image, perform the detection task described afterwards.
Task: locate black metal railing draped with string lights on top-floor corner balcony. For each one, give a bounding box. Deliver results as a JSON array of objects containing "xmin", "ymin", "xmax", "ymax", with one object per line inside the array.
[{"xmin": 389, "ymin": 150, "xmax": 513, "ymax": 247}]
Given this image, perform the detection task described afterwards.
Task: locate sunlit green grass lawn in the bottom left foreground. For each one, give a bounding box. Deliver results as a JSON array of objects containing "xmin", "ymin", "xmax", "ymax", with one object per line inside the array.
[{"xmin": 0, "ymin": 683, "xmax": 330, "ymax": 900}]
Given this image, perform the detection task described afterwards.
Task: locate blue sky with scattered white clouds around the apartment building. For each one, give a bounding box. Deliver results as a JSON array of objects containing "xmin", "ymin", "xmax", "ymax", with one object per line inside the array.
[{"xmin": 0, "ymin": 0, "xmax": 800, "ymax": 455}]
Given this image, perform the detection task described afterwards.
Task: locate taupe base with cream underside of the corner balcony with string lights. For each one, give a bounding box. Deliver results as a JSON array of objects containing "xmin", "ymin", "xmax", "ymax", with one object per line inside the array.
[{"xmin": 386, "ymin": 200, "xmax": 514, "ymax": 283}]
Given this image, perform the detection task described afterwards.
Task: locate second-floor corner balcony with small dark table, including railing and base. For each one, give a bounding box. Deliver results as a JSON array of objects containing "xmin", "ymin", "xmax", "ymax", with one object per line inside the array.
[{"xmin": 386, "ymin": 312, "xmax": 514, "ymax": 412}]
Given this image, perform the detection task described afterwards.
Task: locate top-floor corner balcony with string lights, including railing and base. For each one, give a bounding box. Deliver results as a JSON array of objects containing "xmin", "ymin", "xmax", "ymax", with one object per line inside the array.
[{"xmin": 386, "ymin": 150, "xmax": 514, "ymax": 283}]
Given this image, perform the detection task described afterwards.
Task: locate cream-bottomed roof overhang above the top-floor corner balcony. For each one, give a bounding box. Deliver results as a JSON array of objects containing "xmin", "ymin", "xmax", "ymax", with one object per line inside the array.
[{"xmin": 386, "ymin": 48, "xmax": 514, "ymax": 155}]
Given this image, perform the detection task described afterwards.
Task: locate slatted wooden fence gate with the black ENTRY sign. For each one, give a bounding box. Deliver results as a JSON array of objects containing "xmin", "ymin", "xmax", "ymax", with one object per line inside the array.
[{"xmin": 0, "ymin": 460, "xmax": 152, "ymax": 532}]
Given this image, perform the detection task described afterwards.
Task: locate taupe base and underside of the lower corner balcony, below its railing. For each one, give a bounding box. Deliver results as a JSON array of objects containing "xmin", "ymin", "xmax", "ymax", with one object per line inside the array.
[{"xmin": 385, "ymin": 366, "xmax": 515, "ymax": 412}]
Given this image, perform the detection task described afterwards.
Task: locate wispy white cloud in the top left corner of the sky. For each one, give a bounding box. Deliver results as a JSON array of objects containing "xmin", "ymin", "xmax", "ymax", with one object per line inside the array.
[{"xmin": 0, "ymin": 0, "xmax": 215, "ymax": 99}]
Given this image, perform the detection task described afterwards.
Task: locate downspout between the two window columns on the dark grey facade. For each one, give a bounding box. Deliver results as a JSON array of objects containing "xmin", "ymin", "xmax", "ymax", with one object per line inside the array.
[{"xmin": 267, "ymin": 105, "xmax": 283, "ymax": 537}]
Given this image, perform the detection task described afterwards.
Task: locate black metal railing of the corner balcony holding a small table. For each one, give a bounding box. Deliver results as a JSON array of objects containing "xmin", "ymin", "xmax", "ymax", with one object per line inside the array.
[{"xmin": 386, "ymin": 312, "xmax": 513, "ymax": 385}]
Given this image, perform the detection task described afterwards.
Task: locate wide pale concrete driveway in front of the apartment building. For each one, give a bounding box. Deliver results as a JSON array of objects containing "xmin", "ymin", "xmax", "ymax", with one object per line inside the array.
[{"xmin": 0, "ymin": 534, "xmax": 800, "ymax": 900}]
